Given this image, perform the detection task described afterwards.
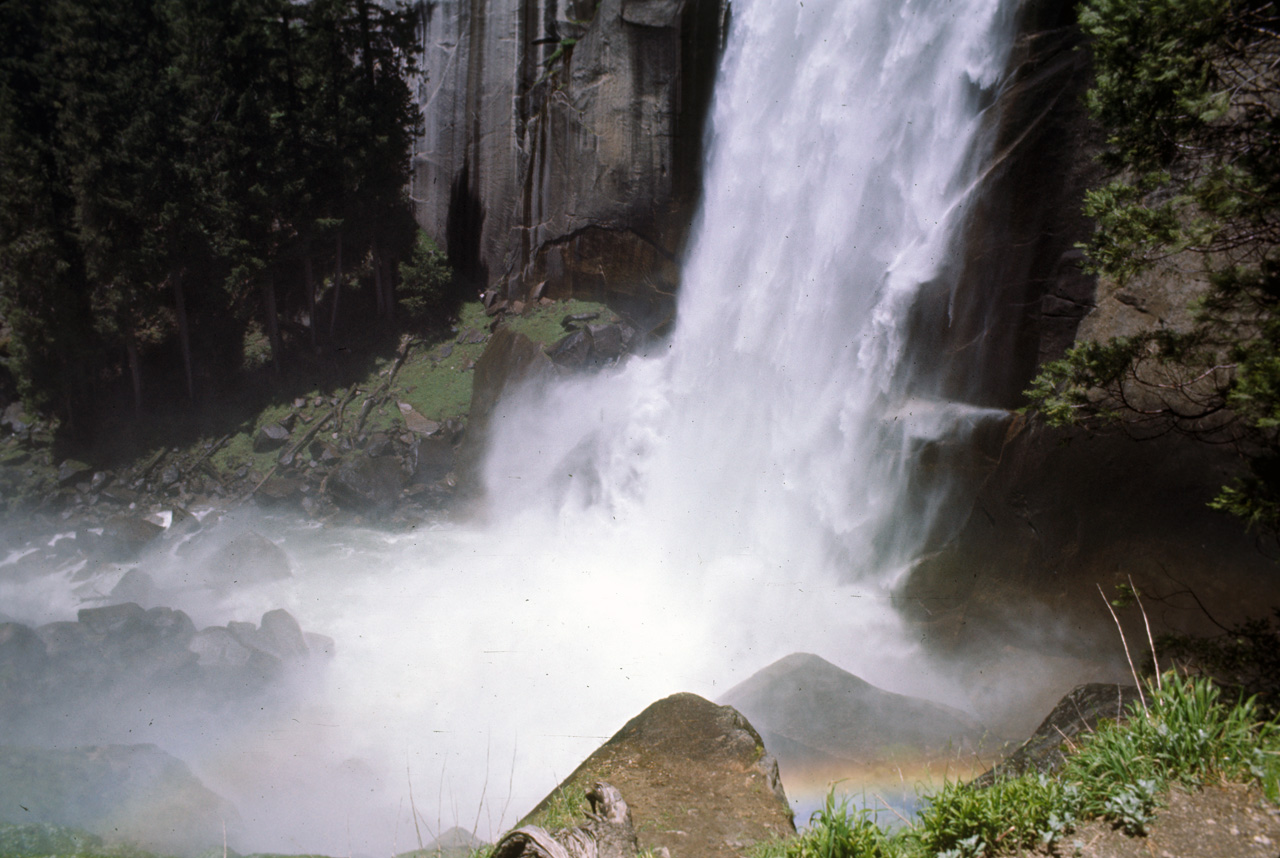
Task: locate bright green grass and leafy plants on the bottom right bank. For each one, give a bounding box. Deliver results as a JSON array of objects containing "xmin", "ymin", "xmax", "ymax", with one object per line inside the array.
[{"xmin": 751, "ymin": 674, "xmax": 1280, "ymax": 858}]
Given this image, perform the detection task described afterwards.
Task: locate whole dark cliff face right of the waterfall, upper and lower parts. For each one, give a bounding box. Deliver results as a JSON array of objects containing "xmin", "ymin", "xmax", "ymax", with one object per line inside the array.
[{"xmin": 899, "ymin": 0, "xmax": 1277, "ymax": 681}]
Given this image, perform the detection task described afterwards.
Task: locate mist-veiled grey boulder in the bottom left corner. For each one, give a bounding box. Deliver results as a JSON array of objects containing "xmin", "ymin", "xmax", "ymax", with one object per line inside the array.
[{"xmin": 0, "ymin": 745, "xmax": 239, "ymax": 855}]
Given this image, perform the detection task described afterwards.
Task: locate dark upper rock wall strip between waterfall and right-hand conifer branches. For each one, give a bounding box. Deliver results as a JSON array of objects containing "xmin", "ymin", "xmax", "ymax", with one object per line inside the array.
[{"xmin": 913, "ymin": 0, "xmax": 1101, "ymax": 407}]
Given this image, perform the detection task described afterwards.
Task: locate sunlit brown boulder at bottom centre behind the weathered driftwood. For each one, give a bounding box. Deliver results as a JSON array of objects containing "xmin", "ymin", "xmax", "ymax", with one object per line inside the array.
[{"xmin": 521, "ymin": 694, "xmax": 795, "ymax": 858}]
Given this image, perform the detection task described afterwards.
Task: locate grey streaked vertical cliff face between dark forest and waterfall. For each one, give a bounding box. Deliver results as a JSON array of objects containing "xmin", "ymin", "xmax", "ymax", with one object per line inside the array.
[{"xmin": 411, "ymin": 0, "xmax": 727, "ymax": 325}]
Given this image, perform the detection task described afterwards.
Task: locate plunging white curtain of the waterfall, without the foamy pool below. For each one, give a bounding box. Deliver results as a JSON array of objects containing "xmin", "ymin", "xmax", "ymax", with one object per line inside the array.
[{"xmin": 488, "ymin": 0, "xmax": 1011, "ymax": 585}]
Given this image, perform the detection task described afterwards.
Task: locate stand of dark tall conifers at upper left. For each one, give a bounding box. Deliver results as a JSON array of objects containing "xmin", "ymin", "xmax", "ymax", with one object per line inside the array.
[{"xmin": 0, "ymin": 0, "xmax": 432, "ymax": 424}]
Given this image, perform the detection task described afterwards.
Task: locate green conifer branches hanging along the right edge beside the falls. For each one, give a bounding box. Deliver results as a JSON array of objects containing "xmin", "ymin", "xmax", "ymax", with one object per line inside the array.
[{"xmin": 1027, "ymin": 0, "xmax": 1280, "ymax": 533}]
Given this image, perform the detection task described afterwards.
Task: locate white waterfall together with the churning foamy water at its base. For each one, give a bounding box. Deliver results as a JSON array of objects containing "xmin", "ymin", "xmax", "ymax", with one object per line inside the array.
[{"xmin": 0, "ymin": 0, "xmax": 1012, "ymax": 854}]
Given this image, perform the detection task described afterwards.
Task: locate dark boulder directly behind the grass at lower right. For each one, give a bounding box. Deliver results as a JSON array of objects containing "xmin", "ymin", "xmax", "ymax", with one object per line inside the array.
[{"xmin": 972, "ymin": 683, "xmax": 1139, "ymax": 786}]
